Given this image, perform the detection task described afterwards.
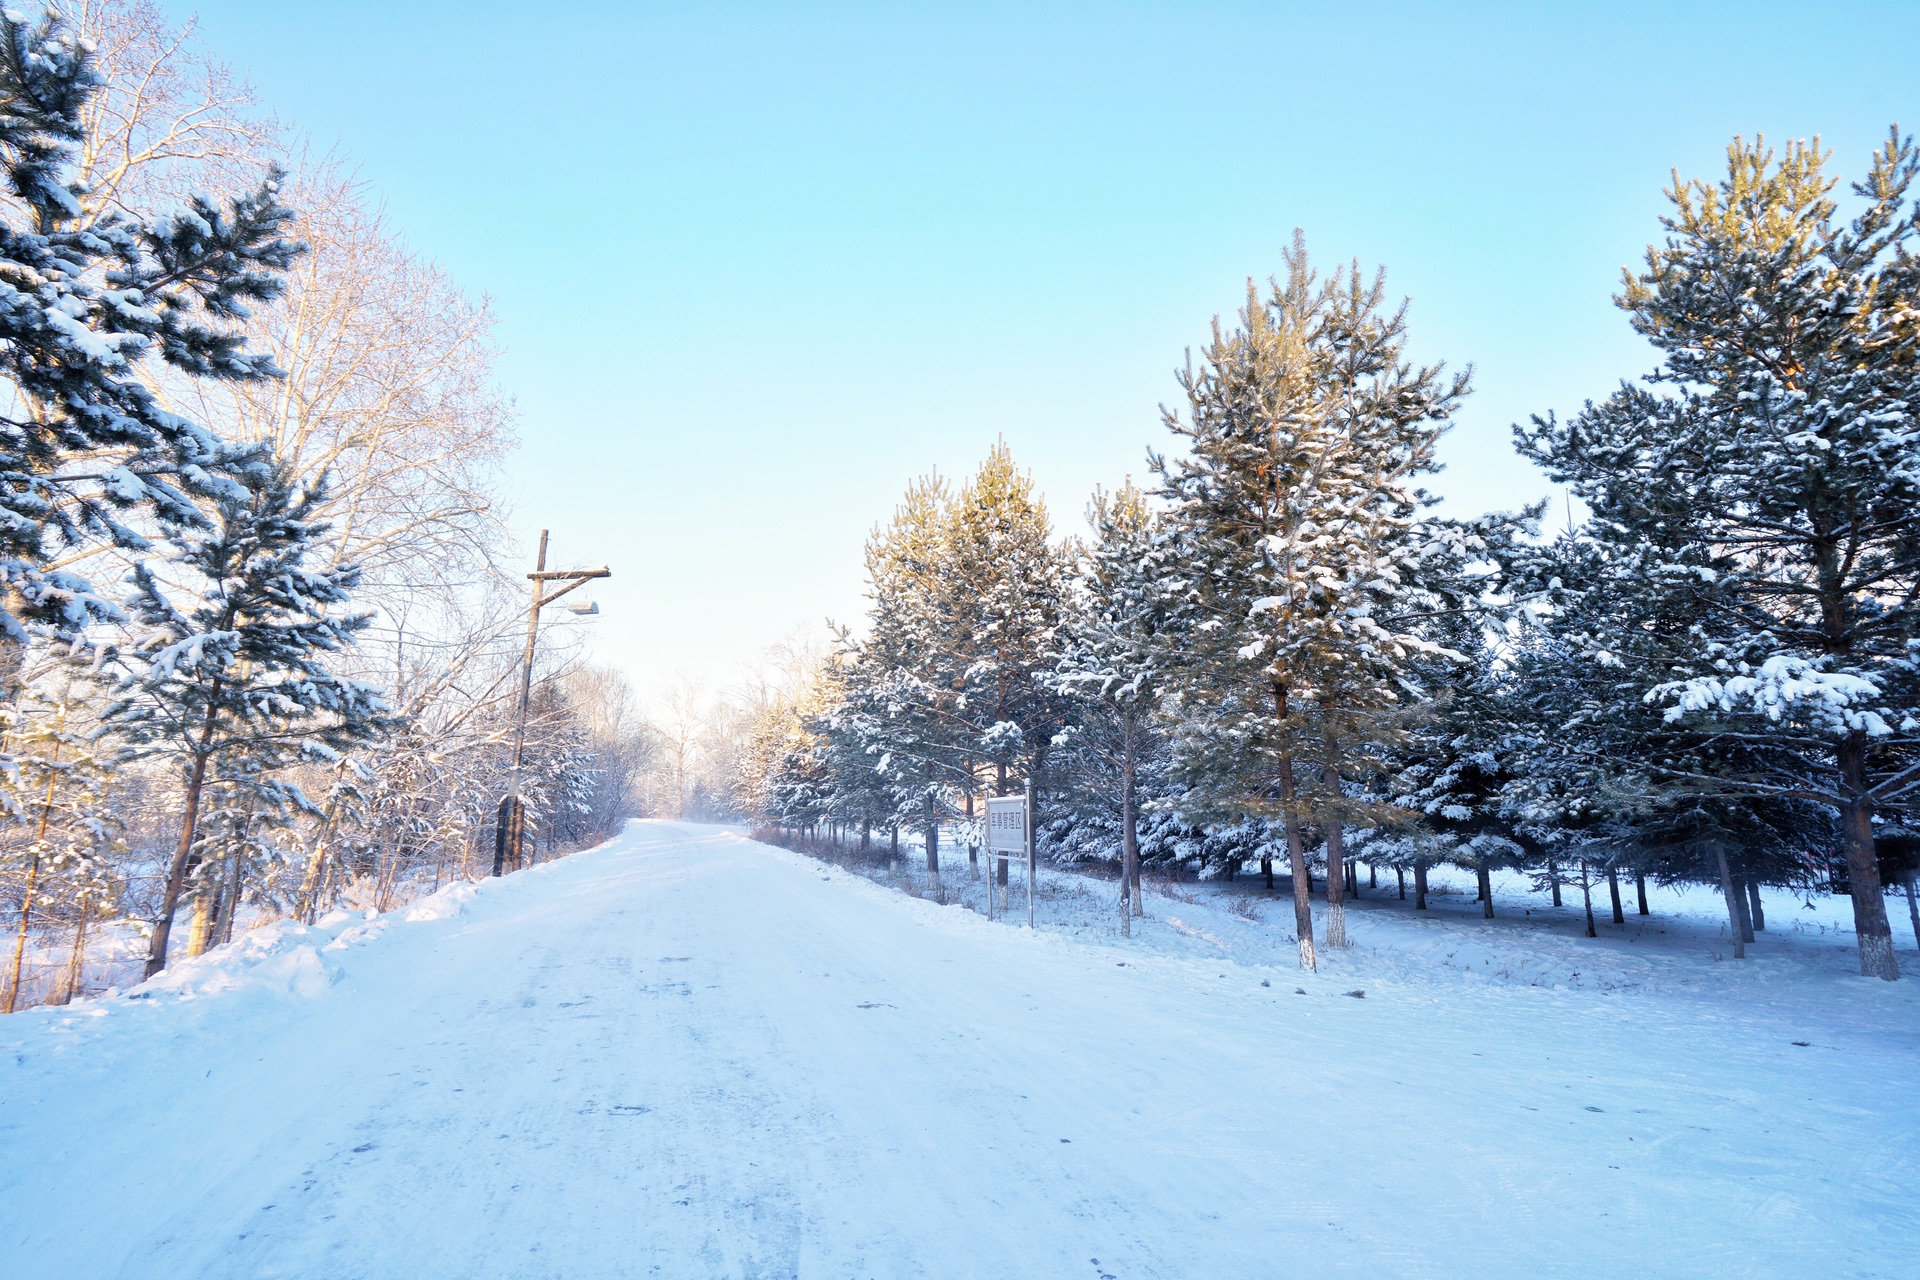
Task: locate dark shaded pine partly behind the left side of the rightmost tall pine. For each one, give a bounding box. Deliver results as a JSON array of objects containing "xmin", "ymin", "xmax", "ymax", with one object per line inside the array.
[{"xmin": 1501, "ymin": 529, "xmax": 1832, "ymax": 960}]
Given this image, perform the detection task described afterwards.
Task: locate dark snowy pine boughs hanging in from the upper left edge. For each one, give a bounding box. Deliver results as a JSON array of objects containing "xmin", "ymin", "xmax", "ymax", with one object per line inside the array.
[{"xmin": 0, "ymin": 10, "xmax": 300, "ymax": 660}]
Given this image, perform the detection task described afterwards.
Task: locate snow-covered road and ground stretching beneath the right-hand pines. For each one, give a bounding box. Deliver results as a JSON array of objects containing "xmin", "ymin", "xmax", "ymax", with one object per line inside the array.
[{"xmin": 0, "ymin": 823, "xmax": 1920, "ymax": 1280}]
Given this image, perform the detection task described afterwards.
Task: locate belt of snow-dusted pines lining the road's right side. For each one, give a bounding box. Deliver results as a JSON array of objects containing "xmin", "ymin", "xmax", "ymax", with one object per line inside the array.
[{"xmin": 739, "ymin": 140, "xmax": 1920, "ymax": 981}]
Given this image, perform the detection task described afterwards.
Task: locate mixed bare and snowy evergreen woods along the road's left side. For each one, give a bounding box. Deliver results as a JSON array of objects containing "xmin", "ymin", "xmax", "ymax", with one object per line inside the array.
[{"xmin": 0, "ymin": 0, "xmax": 735, "ymax": 1011}]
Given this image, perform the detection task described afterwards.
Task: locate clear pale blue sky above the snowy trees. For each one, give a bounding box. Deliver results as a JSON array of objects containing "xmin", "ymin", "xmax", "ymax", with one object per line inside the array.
[{"xmin": 183, "ymin": 0, "xmax": 1920, "ymax": 702}]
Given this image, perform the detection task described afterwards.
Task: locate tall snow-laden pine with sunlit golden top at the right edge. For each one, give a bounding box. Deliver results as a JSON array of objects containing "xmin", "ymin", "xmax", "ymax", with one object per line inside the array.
[{"xmin": 1517, "ymin": 132, "xmax": 1920, "ymax": 981}]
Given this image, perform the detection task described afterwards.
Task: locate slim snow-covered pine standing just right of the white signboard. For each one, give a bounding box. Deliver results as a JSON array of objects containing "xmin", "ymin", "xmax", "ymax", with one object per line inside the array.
[{"xmin": 1056, "ymin": 480, "xmax": 1167, "ymax": 936}]
